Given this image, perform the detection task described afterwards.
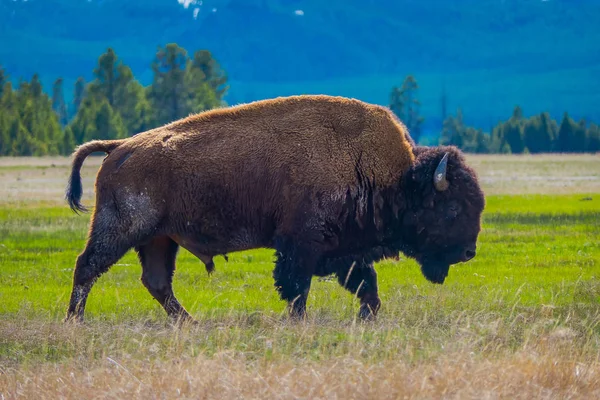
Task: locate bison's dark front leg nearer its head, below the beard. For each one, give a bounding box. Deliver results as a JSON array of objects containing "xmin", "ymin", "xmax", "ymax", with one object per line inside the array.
[{"xmin": 336, "ymin": 259, "xmax": 381, "ymax": 320}]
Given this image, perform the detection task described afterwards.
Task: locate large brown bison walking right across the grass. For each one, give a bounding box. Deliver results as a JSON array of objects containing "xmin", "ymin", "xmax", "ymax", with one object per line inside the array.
[{"xmin": 66, "ymin": 95, "xmax": 484, "ymax": 321}]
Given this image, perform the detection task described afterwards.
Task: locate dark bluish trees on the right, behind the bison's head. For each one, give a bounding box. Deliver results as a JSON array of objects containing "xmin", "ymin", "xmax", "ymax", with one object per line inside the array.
[{"xmin": 389, "ymin": 75, "xmax": 600, "ymax": 154}]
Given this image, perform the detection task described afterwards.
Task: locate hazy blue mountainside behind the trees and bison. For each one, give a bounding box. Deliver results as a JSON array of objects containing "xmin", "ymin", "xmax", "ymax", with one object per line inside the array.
[{"xmin": 0, "ymin": 0, "xmax": 600, "ymax": 134}]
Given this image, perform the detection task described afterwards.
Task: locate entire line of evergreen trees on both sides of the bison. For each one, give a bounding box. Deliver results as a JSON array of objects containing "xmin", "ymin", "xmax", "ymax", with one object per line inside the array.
[{"xmin": 0, "ymin": 60, "xmax": 600, "ymax": 156}]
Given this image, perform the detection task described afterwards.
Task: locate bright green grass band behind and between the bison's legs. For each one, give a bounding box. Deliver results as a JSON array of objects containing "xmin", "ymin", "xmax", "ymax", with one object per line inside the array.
[{"xmin": 0, "ymin": 195, "xmax": 600, "ymax": 350}]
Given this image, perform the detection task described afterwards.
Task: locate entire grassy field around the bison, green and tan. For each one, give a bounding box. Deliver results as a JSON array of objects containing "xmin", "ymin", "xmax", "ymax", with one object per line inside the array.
[{"xmin": 0, "ymin": 155, "xmax": 600, "ymax": 399}]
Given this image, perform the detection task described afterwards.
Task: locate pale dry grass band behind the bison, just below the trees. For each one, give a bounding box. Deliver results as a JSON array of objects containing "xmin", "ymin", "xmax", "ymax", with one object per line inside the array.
[{"xmin": 0, "ymin": 154, "xmax": 600, "ymax": 204}]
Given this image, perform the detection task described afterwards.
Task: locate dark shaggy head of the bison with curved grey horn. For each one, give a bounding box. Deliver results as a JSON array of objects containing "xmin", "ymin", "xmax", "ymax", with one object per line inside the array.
[{"xmin": 401, "ymin": 146, "xmax": 485, "ymax": 284}]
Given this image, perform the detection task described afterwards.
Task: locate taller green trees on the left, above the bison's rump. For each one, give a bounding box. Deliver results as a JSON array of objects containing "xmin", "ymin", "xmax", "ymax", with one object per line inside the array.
[{"xmin": 0, "ymin": 43, "xmax": 228, "ymax": 156}]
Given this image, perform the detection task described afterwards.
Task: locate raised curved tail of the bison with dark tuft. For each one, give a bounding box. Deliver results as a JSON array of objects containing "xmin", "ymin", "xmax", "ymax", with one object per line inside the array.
[{"xmin": 65, "ymin": 139, "xmax": 125, "ymax": 213}]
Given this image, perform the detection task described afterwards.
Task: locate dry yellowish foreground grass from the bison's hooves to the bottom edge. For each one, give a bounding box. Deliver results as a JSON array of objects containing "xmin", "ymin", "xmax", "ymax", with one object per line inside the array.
[{"xmin": 0, "ymin": 318, "xmax": 600, "ymax": 399}]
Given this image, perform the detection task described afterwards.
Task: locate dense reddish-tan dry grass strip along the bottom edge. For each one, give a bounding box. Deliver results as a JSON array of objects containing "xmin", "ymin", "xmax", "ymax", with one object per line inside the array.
[{"xmin": 0, "ymin": 353, "xmax": 600, "ymax": 399}]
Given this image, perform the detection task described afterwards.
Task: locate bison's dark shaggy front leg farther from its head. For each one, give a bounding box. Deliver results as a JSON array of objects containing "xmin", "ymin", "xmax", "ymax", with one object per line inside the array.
[{"xmin": 273, "ymin": 240, "xmax": 318, "ymax": 319}]
